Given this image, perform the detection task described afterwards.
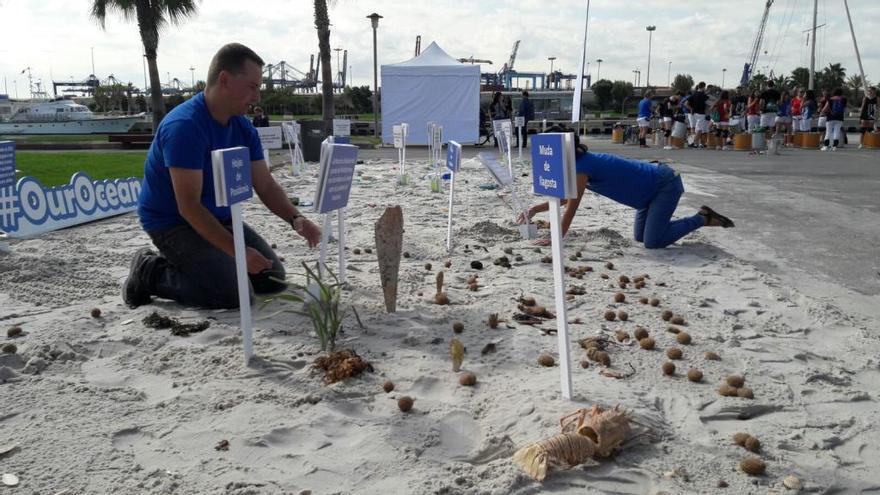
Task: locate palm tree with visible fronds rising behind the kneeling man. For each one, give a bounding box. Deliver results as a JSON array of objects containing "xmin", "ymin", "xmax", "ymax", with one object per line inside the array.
[{"xmin": 91, "ymin": 0, "xmax": 196, "ymax": 132}]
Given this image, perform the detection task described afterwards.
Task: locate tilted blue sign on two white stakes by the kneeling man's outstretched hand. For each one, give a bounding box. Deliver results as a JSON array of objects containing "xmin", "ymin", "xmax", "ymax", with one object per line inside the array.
[{"xmin": 315, "ymin": 139, "xmax": 358, "ymax": 283}]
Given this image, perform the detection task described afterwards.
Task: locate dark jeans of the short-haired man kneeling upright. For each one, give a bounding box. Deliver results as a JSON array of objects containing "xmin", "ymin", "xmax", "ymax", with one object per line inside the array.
[{"xmin": 144, "ymin": 221, "xmax": 285, "ymax": 309}]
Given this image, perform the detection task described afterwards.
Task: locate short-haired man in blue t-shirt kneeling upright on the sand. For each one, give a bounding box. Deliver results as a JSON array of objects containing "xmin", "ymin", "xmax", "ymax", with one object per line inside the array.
[{"xmin": 122, "ymin": 43, "xmax": 321, "ymax": 308}]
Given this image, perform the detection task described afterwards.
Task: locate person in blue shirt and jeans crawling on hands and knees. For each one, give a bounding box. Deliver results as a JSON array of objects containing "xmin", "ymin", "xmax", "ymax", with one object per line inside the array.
[{"xmin": 519, "ymin": 135, "xmax": 733, "ymax": 249}]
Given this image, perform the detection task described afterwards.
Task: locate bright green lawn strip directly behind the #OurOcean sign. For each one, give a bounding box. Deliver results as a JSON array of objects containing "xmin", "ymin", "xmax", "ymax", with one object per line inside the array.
[{"xmin": 15, "ymin": 151, "xmax": 147, "ymax": 186}]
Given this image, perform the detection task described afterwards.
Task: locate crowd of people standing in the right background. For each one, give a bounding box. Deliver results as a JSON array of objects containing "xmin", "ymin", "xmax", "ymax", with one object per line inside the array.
[{"xmin": 636, "ymin": 81, "xmax": 877, "ymax": 151}]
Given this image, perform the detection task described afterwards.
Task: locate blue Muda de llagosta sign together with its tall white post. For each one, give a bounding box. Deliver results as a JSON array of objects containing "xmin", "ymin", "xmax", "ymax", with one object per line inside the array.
[{"xmin": 532, "ymin": 132, "xmax": 577, "ymax": 400}]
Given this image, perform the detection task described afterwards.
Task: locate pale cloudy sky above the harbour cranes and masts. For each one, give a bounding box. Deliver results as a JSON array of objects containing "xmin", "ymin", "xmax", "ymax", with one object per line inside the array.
[{"xmin": 0, "ymin": 0, "xmax": 880, "ymax": 97}]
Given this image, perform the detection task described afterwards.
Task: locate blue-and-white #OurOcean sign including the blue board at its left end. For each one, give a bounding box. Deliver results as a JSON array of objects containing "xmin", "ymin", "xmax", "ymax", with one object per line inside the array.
[{"xmin": 0, "ymin": 141, "xmax": 141, "ymax": 237}]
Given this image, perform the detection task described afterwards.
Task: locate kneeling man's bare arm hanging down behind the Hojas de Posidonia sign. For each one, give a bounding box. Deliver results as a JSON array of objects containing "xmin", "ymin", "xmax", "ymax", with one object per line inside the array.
[{"xmin": 168, "ymin": 167, "xmax": 272, "ymax": 273}]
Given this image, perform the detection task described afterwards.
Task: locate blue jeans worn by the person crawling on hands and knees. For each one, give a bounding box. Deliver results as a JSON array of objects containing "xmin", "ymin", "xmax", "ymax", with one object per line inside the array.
[{"xmin": 634, "ymin": 164, "xmax": 704, "ymax": 249}]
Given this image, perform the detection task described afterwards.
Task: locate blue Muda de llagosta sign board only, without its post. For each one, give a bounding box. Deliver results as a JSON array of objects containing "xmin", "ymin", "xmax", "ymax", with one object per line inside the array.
[{"xmin": 532, "ymin": 132, "xmax": 577, "ymax": 199}]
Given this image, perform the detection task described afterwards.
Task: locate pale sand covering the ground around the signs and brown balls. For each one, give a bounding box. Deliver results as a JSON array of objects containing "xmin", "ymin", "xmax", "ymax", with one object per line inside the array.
[{"xmin": 0, "ymin": 152, "xmax": 880, "ymax": 494}]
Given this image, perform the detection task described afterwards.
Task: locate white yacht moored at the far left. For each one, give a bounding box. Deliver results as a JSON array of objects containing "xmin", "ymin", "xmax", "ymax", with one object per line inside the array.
[{"xmin": 0, "ymin": 99, "xmax": 146, "ymax": 135}]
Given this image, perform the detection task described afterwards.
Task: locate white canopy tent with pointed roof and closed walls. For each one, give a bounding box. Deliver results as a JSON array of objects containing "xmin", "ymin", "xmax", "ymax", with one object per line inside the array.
[{"xmin": 382, "ymin": 43, "xmax": 480, "ymax": 144}]
